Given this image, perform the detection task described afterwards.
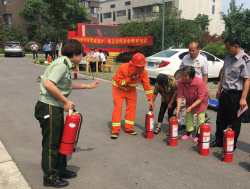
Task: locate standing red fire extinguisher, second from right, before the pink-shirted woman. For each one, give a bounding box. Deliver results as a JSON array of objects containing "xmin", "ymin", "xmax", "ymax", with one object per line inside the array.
[{"xmin": 197, "ymin": 118, "xmax": 210, "ymax": 156}]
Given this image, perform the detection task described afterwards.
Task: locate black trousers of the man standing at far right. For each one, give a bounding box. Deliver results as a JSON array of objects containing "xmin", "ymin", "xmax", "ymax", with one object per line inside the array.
[{"xmin": 215, "ymin": 91, "xmax": 242, "ymax": 146}]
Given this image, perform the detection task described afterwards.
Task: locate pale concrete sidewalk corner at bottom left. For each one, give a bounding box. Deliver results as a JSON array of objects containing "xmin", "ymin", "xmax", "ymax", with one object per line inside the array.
[{"xmin": 0, "ymin": 141, "xmax": 31, "ymax": 189}]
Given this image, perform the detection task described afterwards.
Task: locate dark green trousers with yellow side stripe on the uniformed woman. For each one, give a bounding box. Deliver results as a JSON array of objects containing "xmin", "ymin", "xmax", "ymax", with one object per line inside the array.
[{"xmin": 35, "ymin": 101, "xmax": 67, "ymax": 182}]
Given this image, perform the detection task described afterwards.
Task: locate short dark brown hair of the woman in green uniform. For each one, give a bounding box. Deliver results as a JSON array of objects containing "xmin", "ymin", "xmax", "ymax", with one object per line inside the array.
[{"xmin": 62, "ymin": 39, "xmax": 84, "ymax": 58}]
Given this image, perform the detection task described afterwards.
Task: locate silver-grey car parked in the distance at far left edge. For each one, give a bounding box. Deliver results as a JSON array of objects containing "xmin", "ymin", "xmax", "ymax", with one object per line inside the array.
[{"xmin": 4, "ymin": 41, "xmax": 25, "ymax": 57}]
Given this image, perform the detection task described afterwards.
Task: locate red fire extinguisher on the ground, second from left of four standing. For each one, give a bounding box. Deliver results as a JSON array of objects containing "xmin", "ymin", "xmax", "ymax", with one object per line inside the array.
[{"xmin": 168, "ymin": 116, "xmax": 178, "ymax": 146}]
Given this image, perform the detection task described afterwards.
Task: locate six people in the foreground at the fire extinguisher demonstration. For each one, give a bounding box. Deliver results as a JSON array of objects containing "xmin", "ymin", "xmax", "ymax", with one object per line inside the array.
[{"xmin": 35, "ymin": 36, "xmax": 250, "ymax": 187}]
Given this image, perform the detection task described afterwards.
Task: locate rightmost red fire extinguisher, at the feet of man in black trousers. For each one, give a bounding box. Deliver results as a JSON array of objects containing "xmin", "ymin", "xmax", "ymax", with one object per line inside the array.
[{"xmin": 222, "ymin": 125, "xmax": 234, "ymax": 162}]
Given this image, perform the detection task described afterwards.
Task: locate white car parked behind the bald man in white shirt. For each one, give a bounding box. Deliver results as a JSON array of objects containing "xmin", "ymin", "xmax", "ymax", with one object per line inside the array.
[{"xmin": 145, "ymin": 49, "xmax": 224, "ymax": 80}]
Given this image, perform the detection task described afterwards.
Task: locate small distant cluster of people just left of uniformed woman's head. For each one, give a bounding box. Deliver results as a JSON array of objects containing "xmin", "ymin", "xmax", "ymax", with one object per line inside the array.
[{"xmin": 43, "ymin": 41, "xmax": 62, "ymax": 60}]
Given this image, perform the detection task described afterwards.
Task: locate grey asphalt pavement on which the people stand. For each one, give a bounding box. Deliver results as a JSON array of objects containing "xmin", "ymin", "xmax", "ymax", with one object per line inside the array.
[{"xmin": 0, "ymin": 57, "xmax": 250, "ymax": 189}]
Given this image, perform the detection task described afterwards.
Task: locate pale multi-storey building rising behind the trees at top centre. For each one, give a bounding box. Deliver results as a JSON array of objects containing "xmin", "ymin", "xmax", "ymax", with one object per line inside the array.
[{"xmin": 99, "ymin": 0, "xmax": 225, "ymax": 35}]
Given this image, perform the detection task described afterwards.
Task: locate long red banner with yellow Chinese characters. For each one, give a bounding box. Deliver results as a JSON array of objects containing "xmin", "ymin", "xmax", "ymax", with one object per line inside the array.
[{"xmin": 72, "ymin": 36, "xmax": 153, "ymax": 46}]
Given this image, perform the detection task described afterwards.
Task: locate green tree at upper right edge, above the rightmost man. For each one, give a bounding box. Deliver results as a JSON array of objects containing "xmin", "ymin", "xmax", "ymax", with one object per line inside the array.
[{"xmin": 222, "ymin": 0, "xmax": 250, "ymax": 51}]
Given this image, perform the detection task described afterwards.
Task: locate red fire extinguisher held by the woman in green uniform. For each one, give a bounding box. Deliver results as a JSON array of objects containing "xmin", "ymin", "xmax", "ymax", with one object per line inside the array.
[{"xmin": 59, "ymin": 107, "xmax": 82, "ymax": 155}]
